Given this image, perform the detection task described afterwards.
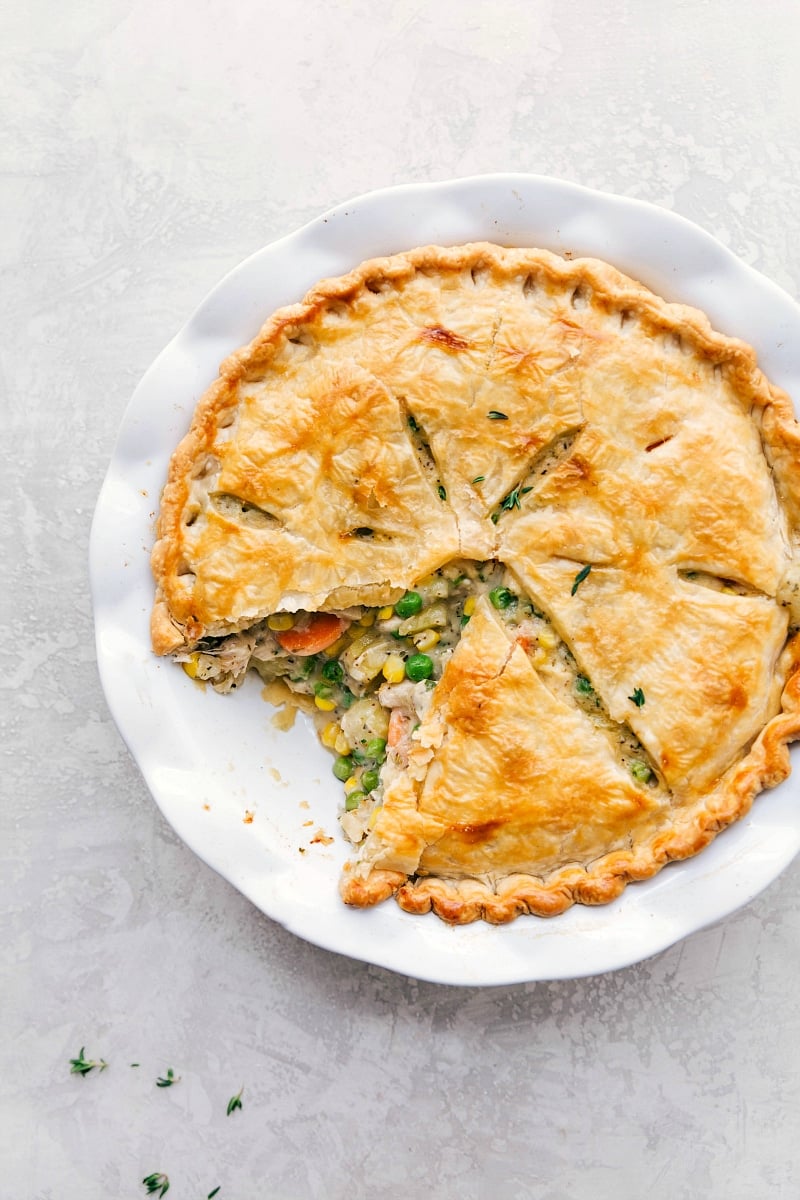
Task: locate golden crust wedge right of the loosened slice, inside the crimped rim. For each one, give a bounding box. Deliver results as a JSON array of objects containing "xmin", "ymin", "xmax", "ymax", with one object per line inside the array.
[{"xmin": 503, "ymin": 554, "xmax": 788, "ymax": 802}]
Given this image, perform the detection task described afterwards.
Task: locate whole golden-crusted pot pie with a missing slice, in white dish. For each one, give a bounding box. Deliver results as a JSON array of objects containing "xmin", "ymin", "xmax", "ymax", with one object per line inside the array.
[{"xmin": 152, "ymin": 244, "xmax": 800, "ymax": 923}]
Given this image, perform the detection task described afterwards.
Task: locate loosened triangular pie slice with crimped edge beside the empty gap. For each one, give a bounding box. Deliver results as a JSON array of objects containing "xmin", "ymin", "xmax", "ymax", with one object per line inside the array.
[{"xmin": 343, "ymin": 598, "xmax": 669, "ymax": 920}]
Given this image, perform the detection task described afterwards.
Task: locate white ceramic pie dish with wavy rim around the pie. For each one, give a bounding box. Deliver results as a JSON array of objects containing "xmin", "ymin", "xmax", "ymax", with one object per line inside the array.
[{"xmin": 90, "ymin": 175, "xmax": 800, "ymax": 985}]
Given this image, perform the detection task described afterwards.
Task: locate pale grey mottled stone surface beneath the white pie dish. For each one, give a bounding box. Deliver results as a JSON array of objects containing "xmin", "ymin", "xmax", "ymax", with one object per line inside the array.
[{"xmin": 6, "ymin": 0, "xmax": 800, "ymax": 1200}]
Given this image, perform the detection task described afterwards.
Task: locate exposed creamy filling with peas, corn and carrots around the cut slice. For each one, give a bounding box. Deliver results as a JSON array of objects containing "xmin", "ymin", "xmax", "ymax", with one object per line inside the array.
[{"xmin": 175, "ymin": 558, "xmax": 668, "ymax": 844}]
